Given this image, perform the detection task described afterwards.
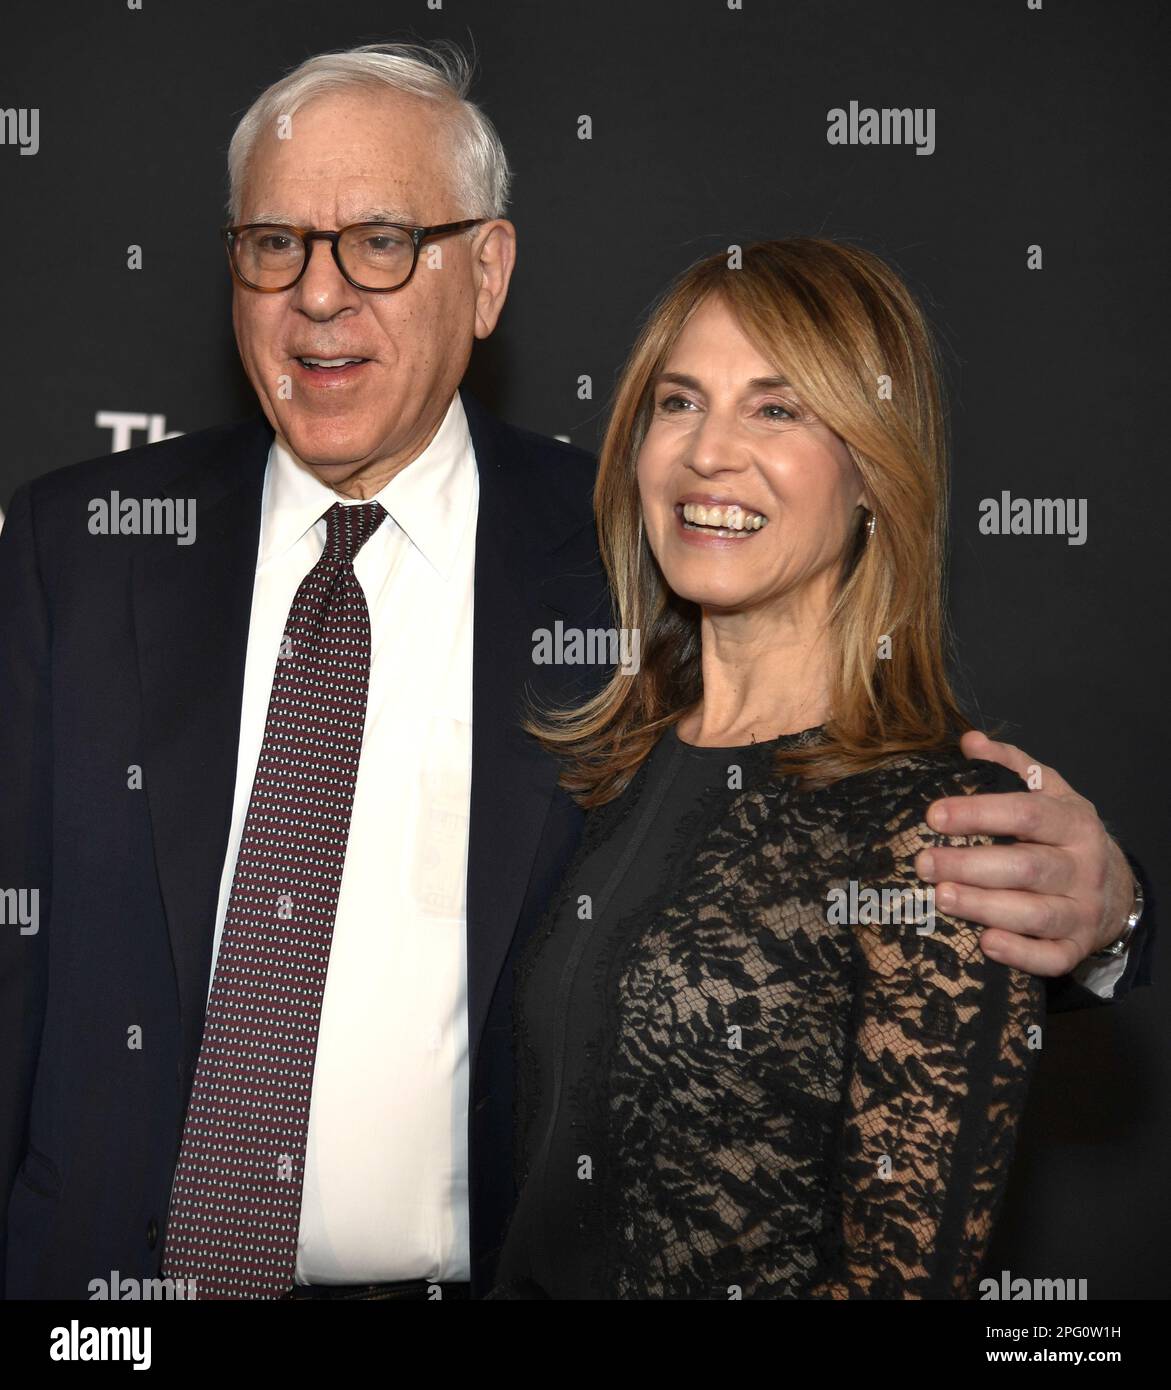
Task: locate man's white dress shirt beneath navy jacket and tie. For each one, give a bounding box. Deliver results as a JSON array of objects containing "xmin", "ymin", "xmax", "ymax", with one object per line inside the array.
[{"xmin": 205, "ymin": 393, "xmax": 478, "ymax": 1284}]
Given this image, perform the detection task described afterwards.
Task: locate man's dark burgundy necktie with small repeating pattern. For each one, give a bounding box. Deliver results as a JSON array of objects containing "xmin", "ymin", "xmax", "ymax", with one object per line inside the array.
[{"xmin": 163, "ymin": 502, "xmax": 387, "ymax": 1298}]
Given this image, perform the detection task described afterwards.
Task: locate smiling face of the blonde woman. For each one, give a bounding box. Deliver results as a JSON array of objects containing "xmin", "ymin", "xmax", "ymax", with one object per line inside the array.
[{"xmin": 638, "ymin": 296, "xmax": 865, "ymax": 612}]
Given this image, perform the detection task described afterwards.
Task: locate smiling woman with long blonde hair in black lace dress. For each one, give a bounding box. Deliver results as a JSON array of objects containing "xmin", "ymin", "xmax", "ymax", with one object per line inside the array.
[{"xmin": 491, "ymin": 239, "xmax": 1042, "ymax": 1298}]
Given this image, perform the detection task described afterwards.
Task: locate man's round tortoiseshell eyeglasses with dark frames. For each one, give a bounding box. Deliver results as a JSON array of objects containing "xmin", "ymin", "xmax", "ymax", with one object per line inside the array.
[{"xmin": 220, "ymin": 217, "xmax": 485, "ymax": 295}]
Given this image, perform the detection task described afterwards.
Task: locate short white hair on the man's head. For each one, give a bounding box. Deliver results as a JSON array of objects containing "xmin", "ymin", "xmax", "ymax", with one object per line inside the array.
[{"xmin": 228, "ymin": 39, "xmax": 512, "ymax": 222}]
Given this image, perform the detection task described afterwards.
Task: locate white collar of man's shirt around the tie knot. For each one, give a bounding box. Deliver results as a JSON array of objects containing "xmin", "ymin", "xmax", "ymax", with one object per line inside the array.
[{"xmin": 259, "ymin": 392, "xmax": 476, "ymax": 578}]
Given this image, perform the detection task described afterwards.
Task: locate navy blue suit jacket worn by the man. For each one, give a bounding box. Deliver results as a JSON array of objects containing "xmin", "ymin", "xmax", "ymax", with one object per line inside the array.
[{"xmin": 0, "ymin": 392, "xmax": 609, "ymax": 1298}]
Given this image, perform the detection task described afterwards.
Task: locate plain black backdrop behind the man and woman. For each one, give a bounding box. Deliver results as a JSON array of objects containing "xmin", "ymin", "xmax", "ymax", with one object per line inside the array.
[{"xmin": 0, "ymin": 0, "xmax": 1171, "ymax": 1298}]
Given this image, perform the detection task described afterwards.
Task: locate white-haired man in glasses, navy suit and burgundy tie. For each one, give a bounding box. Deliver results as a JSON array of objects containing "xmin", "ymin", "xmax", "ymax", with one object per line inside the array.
[{"xmin": 0, "ymin": 46, "xmax": 1143, "ymax": 1298}]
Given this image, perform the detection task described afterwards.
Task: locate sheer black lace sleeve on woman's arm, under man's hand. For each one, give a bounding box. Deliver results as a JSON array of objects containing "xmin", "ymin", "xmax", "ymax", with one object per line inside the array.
[{"xmin": 807, "ymin": 763, "xmax": 1043, "ymax": 1298}]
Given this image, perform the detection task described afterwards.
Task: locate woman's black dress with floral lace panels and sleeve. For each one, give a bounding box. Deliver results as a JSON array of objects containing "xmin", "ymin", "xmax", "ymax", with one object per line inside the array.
[{"xmin": 488, "ymin": 730, "xmax": 1043, "ymax": 1300}]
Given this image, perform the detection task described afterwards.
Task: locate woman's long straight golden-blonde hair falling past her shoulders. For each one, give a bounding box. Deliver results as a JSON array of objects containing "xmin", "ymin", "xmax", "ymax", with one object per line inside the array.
[{"xmin": 526, "ymin": 238, "xmax": 990, "ymax": 806}]
